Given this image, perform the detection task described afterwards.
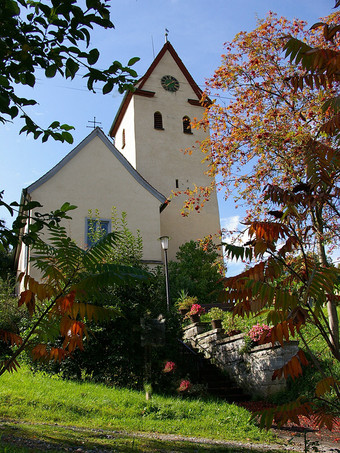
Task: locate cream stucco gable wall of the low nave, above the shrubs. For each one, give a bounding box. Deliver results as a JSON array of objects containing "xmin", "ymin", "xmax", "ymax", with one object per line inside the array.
[{"xmin": 19, "ymin": 132, "xmax": 162, "ymax": 274}]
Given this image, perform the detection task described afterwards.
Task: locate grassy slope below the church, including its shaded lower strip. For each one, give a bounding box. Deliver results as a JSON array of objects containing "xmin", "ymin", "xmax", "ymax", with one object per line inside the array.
[{"xmin": 0, "ymin": 368, "xmax": 294, "ymax": 453}]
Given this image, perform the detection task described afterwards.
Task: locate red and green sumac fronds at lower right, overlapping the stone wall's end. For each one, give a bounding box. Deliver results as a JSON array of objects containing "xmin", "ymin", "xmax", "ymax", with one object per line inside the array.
[{"xmin": 225, "ymin": 192, "xmax": 339, "ymax": 426}]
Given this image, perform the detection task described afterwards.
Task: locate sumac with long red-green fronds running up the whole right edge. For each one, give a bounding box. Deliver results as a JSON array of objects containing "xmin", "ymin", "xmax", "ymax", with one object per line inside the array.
[{"xmin": 216, "ymin": 8, "xmax": 340, "ymax": 428}]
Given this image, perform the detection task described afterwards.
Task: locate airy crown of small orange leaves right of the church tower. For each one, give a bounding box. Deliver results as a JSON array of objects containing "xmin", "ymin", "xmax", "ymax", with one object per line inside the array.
[{"xmin": 190, "ymin": 13, "xmax": 339, "ymax": 228}]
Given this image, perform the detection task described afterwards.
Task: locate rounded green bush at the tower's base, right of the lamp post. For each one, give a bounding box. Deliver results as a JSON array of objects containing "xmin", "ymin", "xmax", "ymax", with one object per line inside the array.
[{"xmin": 169, "ymin": 241, "xmax": 222, "ymax": 303}]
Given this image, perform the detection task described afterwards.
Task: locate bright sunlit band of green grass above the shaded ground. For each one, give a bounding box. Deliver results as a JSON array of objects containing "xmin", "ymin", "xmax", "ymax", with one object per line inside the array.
[{"xmin": 0, "ymin": 369, "xmax": 282, "ymax": 452}]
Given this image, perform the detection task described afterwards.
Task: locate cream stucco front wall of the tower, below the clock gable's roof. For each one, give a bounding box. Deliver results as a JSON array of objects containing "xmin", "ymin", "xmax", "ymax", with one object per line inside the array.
[{"xmin": 130, "ymin": 48, "xmax": 220, "ymax": 259}]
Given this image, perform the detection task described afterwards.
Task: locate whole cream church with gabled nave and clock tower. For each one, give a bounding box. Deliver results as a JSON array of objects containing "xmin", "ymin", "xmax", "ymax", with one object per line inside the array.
[{"xmin": 17, "ymin": 42, "xmax": 220, "ymax": 278}]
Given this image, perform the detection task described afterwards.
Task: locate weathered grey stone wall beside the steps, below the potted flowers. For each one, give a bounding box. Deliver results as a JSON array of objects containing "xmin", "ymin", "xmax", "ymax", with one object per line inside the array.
[{"xmin": 183, "ymin": 322, "xmax": 299, "ymax": 397}]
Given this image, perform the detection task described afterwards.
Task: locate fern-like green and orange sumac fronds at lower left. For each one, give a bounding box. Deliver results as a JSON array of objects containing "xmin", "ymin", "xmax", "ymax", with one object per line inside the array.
[{"xmin": 0, "ymin": 219, "xmax": 147, "ymax": 374}]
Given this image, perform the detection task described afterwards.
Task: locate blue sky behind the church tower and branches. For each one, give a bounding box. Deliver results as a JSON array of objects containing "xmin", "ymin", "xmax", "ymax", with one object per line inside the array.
[{"xmin": 0, "ymin": 0, "xmax": 334, "ymax": 273}]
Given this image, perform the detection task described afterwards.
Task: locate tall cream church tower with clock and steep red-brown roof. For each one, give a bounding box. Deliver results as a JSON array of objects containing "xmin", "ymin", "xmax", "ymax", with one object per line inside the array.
[{"xmin": 110, "ymin": 42, "xmax": 220, "ymax": 259}]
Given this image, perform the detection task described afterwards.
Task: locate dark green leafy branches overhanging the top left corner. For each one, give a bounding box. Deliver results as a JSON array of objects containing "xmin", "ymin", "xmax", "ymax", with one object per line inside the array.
[{"xmin": 0, "ymin": 0, "xmax": 139, "ymax": 143}]
